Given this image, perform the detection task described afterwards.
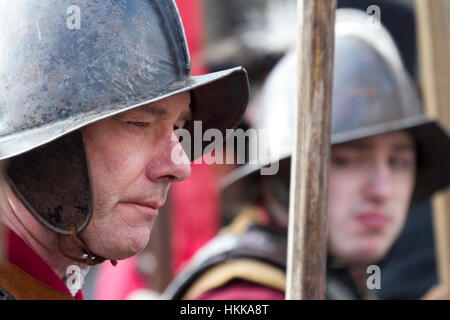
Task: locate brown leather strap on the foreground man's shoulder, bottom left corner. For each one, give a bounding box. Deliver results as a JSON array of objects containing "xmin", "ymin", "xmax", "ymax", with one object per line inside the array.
[{"xmin": 0, "ymin": 260, "xmax": 73, "ymax": 300}]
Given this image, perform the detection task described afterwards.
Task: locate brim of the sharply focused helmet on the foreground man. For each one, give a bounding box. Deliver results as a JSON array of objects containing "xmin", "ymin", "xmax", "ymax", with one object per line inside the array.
[{"xmin": 0, "ymin": 67, "xmax": 249, "ymax": 160}]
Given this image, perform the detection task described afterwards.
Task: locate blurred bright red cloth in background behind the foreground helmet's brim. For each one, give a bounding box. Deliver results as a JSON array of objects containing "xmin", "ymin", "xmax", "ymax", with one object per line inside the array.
[{"xmin": 170, "ymin": 0, "xmax": 220, "ymax": 274}]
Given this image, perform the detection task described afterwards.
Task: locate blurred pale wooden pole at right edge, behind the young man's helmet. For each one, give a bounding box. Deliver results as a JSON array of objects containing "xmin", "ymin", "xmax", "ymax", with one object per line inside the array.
[{"xmin": 416, "ymin": 0, "xmax": 450, "ymax": 292}]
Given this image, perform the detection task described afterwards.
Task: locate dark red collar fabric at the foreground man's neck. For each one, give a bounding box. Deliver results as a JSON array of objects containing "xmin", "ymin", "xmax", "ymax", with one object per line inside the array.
[{"xmin": 6, "ymin": 229, "xmax": 83, "ymax": 300}]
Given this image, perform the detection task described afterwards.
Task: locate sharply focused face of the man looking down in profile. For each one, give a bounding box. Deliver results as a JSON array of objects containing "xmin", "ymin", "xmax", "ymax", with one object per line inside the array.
[{"xmin": 82, "ymin": 93, "xmax": 191, "ymax": 259}]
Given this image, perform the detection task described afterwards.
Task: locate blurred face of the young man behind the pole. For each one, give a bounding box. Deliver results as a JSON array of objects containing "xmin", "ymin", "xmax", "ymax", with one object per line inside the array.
[{"xmin": 328, "ymin": 131, "xmax": 416, "ymax": 264}]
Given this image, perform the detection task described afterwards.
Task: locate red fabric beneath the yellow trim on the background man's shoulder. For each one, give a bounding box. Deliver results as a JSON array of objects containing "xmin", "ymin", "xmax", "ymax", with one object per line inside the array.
[{"xmin": 195, "ymin": 280, "xmax": 284, "ymax": 300}]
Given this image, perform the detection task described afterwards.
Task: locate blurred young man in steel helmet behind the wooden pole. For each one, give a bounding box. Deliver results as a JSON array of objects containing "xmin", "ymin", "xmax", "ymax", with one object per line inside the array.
[{"xmin": 166, "ymin": 9, "xmax": 450, "ymax": 299}]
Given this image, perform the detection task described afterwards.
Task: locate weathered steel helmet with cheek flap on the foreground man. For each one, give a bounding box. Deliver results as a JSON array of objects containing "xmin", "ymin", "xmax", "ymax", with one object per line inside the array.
[{"xmin": 0, "ymin": 0, "xmax": 248, "ymax": 235}]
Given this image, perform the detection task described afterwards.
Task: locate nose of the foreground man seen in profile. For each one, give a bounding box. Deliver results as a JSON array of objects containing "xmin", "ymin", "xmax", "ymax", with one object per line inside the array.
[{"xmin": 147, "ymin": 133, "xmax": 191, "ymax": 182}]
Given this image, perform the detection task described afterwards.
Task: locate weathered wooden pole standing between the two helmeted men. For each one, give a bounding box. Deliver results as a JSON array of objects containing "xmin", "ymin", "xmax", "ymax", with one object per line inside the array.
[{"xmin": 286, "ymin": 0, "xmax": 336, "ymax": 300}]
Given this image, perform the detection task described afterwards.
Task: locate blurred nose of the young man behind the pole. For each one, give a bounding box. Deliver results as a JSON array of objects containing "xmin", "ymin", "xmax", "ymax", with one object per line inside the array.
[{"xmin": 364, "ymin": 161, "xmax": 393, "ymax": 202}]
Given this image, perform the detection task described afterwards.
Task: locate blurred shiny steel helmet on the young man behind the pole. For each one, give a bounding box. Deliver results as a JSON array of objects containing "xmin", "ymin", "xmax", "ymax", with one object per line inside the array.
[{"xmin": 222, "ymin": 9, "xmax": 450, "ymax": 199}]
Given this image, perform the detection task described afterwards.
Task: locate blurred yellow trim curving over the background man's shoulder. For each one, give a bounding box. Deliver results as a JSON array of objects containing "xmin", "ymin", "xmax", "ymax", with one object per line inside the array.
[{"xmin": 183, "ymin": 259, "xmax": 286, "ymax": 300}]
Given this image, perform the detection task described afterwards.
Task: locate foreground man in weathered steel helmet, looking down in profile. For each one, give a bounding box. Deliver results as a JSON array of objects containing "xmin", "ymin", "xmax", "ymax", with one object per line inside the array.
[{"xmin": 0, "ymin": 0, "xmax": 248, "ymax": 299}]
